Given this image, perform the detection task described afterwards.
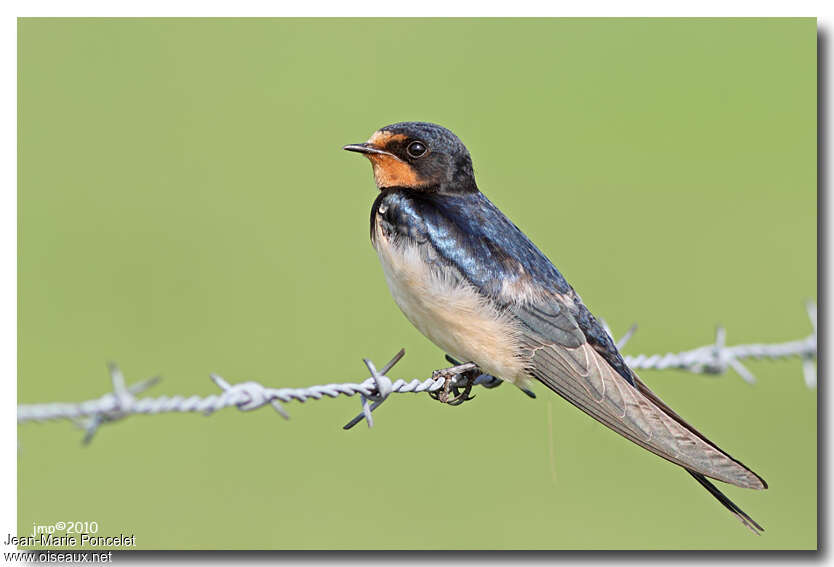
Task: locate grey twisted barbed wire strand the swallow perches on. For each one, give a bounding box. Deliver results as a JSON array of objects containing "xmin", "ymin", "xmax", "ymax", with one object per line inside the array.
[{"xmin": 17, "ymin": 302, "xmax": 817, "ymax": 443}]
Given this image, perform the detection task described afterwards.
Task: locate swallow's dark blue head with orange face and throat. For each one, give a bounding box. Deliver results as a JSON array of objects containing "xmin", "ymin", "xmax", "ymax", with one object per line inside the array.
[{"xmin": 344, "ymin": 122, "xmax": 478, "ymax": 193}]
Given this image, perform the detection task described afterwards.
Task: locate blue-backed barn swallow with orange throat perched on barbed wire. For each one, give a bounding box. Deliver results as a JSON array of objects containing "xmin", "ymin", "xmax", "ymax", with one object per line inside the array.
[{"xmin": 344, "ymin": 122, "xmax": 767, "ymax": 534}]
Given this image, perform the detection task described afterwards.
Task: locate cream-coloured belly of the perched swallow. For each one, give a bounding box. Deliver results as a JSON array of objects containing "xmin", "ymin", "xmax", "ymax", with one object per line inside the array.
[{"xmin": 375, "ymin": 226, "xmax": 527, "ymax": 385}]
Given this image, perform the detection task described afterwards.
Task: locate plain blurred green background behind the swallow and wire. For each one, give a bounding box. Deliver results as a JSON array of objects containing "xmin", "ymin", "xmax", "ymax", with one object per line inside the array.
[{"xmin": 18, "ymin": 19, "xmax": 817, "ymax": 549}]
